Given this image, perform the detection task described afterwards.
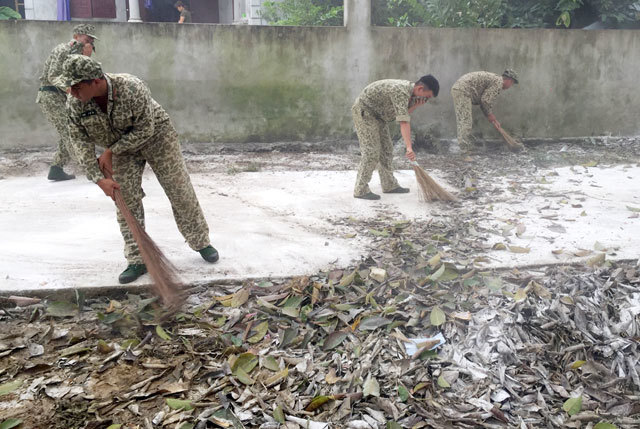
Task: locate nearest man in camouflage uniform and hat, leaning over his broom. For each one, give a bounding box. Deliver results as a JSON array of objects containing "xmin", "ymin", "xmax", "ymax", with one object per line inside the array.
[{"xmin": 62, "ymin": 55, "xmax": 218, "ymax": 283}]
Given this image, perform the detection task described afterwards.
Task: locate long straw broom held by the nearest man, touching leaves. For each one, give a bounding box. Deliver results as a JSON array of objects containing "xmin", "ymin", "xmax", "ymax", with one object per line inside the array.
[{"xmin": 102, "ymin": 164, "xmax": 184, "ymax": 311}]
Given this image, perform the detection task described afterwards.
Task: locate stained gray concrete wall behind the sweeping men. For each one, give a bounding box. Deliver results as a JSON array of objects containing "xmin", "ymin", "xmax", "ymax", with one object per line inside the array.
[{"xmin": 0, "ymin": 17, "xmax": 640, "ymax": 148}]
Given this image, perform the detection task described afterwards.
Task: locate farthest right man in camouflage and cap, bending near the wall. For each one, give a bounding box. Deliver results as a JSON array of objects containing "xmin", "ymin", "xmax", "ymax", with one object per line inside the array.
[{"xmin": 451, "ymin": 69, "xmax": 518, "ymax": 152}]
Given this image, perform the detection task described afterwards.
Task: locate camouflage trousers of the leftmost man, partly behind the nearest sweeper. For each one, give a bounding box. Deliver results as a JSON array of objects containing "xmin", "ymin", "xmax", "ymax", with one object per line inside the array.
[{"xmin": 36, "ymin": 91, "xmax": 75, "ymax": 167}]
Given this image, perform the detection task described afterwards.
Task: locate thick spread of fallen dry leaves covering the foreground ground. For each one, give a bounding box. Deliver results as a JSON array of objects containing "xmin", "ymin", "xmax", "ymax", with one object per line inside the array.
[{"xmin": 0, "ymin": 139, "xmax": 640, "ymax": 429}]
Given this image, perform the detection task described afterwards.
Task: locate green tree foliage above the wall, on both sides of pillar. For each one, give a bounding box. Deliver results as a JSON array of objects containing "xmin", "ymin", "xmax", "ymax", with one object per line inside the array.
[{"xmin": 262, "ymin": 0, "xmax": 640, "ymax": 28}]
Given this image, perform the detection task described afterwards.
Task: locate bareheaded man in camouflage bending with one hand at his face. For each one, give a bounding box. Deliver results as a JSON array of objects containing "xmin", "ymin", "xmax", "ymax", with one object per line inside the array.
[{"xmin": 351, "ymin": 75, "xmax": 440, "ymax": 200}]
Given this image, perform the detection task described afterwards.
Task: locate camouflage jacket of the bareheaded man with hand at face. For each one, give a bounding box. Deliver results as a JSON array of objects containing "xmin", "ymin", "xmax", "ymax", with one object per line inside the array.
[{"xmin": 354, "ymin": 79, "xmax": 414, "ymax": 122}]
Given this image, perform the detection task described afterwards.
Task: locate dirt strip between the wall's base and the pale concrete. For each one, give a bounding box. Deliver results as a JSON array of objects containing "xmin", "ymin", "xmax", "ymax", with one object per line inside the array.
[{"xmin": 5, "ymin": 138, "xmax": 640, "ymax": 177}]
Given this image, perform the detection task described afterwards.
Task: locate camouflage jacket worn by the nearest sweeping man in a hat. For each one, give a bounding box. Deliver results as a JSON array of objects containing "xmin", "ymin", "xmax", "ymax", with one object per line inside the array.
[{"xmin": 67, "ymin": 73, "xmax": 173, "ymax": 182}]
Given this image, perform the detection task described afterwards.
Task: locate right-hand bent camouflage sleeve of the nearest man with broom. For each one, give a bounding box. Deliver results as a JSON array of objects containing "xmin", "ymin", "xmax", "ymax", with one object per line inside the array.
[{"xmin": 110, "ymin": 81, "xmax": 154, "ymax": 155}]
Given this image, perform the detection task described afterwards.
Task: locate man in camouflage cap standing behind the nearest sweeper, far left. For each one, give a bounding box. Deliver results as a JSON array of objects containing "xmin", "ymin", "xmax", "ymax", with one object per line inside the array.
[{"xmin": 36, "ymin": 24, "xmax": 97, "ymax": 181}]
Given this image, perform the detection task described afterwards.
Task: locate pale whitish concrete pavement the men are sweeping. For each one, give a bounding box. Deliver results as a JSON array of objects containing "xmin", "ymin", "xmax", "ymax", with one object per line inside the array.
[{"xmin": 0, "ymin": 147, "xmax": 640, "ymax": 294}]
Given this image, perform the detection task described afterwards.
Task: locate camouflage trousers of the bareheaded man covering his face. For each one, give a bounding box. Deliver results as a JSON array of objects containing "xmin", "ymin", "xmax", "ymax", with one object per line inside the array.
[{"xmin": 351, "ymin": 103, "xmax": 400, "ymax": 196}]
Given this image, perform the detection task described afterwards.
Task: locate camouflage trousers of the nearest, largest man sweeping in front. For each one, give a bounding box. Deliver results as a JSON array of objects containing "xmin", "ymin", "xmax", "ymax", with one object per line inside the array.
[{"xmin": 113, "ymin": 126, "xmax": 210, "ymax": 264}]
